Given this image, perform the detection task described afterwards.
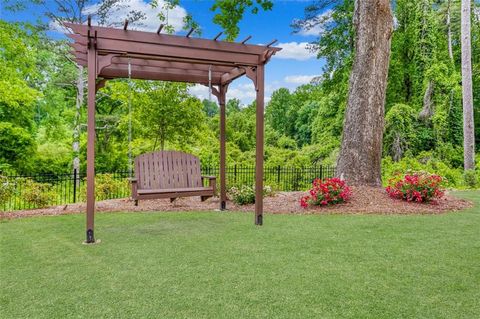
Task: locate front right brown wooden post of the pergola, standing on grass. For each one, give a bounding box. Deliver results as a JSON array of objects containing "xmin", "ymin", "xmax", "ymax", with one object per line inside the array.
[{"xmin": 255, "ymin": 64, "xmax": 265, "ymax": 225}]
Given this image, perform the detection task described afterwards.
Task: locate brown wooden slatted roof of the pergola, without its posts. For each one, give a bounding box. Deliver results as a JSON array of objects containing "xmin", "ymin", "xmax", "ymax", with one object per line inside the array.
[{"xmin": 65, "ymin": 23, "xmax": 281, "ymax": 85}]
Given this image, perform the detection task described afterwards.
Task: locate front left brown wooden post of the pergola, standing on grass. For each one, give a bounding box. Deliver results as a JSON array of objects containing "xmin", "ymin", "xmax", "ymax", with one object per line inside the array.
[{"xmin": 86, "ymin": 39, "xmax": 97, "ymax": 244}]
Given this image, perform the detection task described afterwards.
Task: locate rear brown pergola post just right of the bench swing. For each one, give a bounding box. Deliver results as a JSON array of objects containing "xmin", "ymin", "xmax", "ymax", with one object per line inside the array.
[{"xmin": 218, "ymin": 85, "xmax": 227, "ymax": 210}]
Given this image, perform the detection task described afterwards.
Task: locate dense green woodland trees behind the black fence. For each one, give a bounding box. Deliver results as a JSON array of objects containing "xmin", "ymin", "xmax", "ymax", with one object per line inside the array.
[{"xmin": 0, "ymin": 0, "xmax": 480, "ymax": 186}]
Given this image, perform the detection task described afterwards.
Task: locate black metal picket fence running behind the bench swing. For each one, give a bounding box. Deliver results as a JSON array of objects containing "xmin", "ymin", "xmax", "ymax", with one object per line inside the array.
[{"xmin": 0, "ymin": 165, "xmax": 335, "ymax": 211}]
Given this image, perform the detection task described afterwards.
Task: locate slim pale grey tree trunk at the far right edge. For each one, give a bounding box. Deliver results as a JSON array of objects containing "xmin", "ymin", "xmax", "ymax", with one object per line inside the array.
[{"xmin": 461, "ymin": 0, "xmax": 475, "ymax": 170}]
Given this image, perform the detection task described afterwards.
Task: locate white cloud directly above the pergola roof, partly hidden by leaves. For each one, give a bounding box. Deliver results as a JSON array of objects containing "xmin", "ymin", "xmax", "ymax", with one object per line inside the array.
[{"xmin": 50, "ymin": 0, "xmax": 187, "ymax": 32}]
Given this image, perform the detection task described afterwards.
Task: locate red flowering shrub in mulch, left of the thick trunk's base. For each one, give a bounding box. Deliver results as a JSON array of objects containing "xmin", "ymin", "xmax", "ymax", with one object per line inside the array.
[{"xmin": 300, "ymin": 178, "xmax": 352, "ymax": 208}]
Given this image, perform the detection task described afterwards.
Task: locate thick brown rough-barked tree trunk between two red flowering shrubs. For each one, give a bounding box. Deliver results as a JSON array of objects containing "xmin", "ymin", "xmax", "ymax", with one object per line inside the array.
[{"xmin": 337, "ymin": 0, "xmax": 393, "ymax": 186}]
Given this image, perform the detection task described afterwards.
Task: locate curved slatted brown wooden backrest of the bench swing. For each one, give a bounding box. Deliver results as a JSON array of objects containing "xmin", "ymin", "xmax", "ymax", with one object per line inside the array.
[{"xmin": 135, "ymin": 151, "xmax": 203, "ymax": 189}]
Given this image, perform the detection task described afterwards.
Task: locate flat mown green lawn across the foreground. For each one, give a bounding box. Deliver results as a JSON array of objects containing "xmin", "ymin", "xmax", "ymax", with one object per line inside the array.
[{"xmin": 0, "ymin": 192, "xmax": 480, "ymax": 318}]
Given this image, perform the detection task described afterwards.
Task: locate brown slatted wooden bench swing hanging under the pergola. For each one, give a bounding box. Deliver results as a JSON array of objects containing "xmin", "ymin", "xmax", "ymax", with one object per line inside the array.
[{"xmin": 131, "ymin": 151, "xmax": 216, "ymax": 206}]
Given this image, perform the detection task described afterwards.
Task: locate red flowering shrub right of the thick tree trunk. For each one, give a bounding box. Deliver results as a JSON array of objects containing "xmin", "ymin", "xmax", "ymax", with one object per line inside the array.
[{"xmin": 386, "ymin": 173, "xmax": 445, "ymax": 203}]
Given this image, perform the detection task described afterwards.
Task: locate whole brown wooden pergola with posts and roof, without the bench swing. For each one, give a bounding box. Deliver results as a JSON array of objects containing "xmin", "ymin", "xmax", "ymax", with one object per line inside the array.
[{"xmin": 65, "ymin": 19, "xmax": 281, "ymax": 243}]
